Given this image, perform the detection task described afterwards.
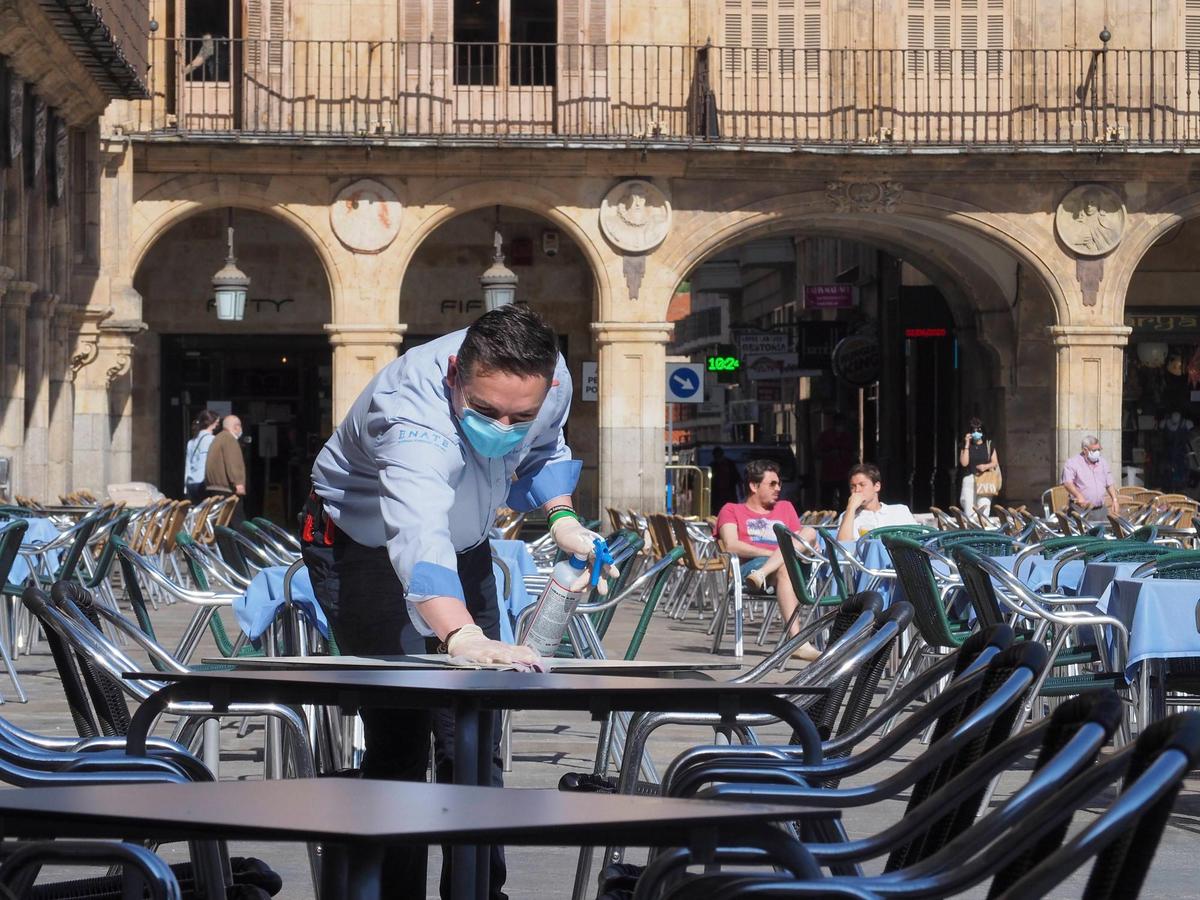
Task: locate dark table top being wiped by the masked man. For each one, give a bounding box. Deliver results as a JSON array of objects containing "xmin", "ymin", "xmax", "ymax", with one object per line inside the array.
[{"xmin": 125, "ymin": 668, "xmax": 828, "ymax": 712}]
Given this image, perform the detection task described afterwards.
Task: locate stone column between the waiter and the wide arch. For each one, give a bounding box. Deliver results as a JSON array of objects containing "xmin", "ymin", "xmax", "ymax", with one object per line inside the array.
[{"xmin": 592, "ymin": 322, "xmax": 674, "ymax": 515}]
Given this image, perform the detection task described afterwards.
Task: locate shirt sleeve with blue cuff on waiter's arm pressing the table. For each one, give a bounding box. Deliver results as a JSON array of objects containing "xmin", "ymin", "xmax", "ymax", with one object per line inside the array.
[{"xmin": 374, "ymin": 421, "xmax": 464, "ymax": 636}]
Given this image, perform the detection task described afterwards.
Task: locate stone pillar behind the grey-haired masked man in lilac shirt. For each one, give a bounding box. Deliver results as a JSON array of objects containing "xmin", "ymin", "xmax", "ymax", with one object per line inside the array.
[{"xmin": 1050, "ymin": 325, "xmax": 1130, "ymax": 484}]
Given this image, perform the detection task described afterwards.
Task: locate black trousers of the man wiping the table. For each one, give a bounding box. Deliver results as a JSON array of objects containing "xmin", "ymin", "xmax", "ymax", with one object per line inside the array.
[{"xmin": 304, "ymin": 518, "xmax": 508, "ymax": 900}]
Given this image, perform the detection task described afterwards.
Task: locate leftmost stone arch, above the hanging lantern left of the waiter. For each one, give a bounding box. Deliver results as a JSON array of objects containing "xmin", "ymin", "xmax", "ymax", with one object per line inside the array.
[{"xmin": 128, "ymin": 179, "xmax": 343, "ymax": 322}]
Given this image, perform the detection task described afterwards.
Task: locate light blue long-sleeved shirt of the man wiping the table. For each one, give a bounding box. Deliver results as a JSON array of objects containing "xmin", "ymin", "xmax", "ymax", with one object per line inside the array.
[{"xmin": 312, "ymin": 329, "xmax": 582, "ymax": 635}]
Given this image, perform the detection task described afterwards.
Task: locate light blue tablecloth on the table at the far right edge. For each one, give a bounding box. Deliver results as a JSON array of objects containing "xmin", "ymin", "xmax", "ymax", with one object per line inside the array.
[{"xmin": 1096, "ymin": 578, "xmax": 1200, "ymax": 680}]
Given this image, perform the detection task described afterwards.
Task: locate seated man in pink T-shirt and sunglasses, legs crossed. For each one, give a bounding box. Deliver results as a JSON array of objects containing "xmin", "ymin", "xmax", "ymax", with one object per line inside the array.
[{"xmin": 716, "ymin": 460, "xmax": 821, "ymax": 660}]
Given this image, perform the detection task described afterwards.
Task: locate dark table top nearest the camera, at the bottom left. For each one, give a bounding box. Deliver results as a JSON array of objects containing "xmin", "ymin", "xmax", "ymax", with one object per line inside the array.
[{"xmin": 0, "ymin": 778, "xmax": 836, "ymax": 846}]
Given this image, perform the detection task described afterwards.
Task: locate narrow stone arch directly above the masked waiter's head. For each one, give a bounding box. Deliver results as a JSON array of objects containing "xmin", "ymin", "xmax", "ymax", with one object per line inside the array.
[{"xmin": 396, "ymin": 180, "xmax": 614, "ymax": 319}]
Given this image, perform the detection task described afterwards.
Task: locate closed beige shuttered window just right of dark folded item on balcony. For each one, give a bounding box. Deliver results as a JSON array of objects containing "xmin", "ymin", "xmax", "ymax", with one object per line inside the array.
[{"xmin": 721, "ymin": 0, "xmax": 824, "ymax": 76}]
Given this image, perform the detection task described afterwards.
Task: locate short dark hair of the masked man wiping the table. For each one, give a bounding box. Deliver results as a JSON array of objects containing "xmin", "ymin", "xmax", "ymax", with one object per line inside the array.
[{"xmin": 457, "ymin": 304, "xmax": 558, "ymax": 382}]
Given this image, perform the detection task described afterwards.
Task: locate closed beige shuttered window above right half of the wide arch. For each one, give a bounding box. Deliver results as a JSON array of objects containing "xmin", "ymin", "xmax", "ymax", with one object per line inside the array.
[{"xmin": 905, "ymin": 0, "xmax": 1008, "ymax": 76}]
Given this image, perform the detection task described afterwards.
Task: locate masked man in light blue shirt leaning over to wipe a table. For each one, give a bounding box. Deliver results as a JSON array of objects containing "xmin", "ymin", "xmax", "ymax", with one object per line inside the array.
[{"xmin": 301, "ymin": 305, "xmax": 616, "ymax": 898}]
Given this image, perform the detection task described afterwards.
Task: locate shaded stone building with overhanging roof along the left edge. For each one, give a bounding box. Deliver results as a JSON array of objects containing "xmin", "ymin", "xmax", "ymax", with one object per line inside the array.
[{"xmin": 0, "ymin": 0, "xmax": 149, "ymax": 499}]
